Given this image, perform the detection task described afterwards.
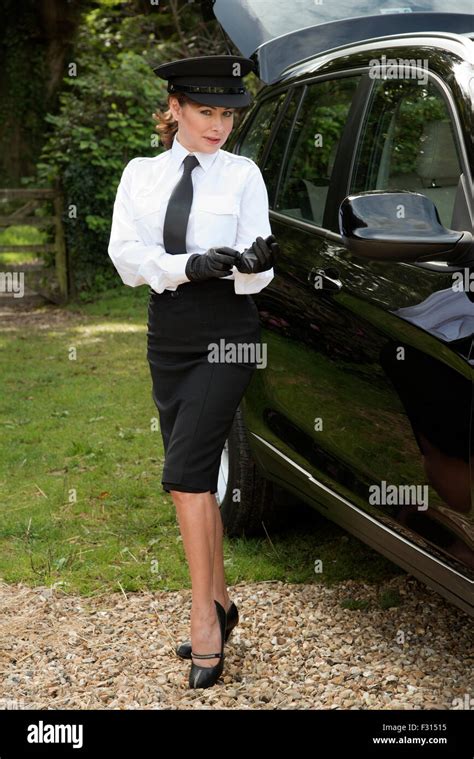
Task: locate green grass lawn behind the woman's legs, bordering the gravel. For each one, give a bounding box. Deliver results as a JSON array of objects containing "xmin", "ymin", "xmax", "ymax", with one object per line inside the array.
[{"xmin": 0, "ymin": 287, "xmax": 401, "ymax": 595}]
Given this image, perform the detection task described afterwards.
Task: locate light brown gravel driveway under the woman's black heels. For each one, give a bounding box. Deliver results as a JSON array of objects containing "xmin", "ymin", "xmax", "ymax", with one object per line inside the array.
[{"xmin": 0, "ymin": 575, "xmax": 473, "ymax": 709}]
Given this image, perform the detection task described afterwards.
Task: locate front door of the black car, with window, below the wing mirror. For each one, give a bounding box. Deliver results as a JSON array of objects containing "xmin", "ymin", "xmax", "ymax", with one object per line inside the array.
[{"xmin": 338, "ymin": 67, "xmax": 474, "ymax": 576}]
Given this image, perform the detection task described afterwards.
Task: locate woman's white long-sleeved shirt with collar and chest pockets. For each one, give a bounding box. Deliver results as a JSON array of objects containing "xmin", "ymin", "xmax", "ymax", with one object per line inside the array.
[{"xmin": 108, "ymin": 135, "xmax": 274, "ymax": 295}]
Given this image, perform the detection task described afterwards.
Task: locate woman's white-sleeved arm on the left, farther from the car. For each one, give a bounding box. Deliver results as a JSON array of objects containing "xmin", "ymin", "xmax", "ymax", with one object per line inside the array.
[{"xmin": 108, "ymin": 159, "xmax": 192, "ymax": 293}]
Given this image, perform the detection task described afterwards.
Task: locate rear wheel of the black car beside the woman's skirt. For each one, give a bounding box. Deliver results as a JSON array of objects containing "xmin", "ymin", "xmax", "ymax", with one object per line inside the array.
[{"xmin": 216, "ymin": 407, "xmax": 294, "ymax": 537}]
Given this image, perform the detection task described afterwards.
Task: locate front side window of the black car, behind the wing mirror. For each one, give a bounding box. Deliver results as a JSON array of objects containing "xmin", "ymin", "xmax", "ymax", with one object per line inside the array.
[{"xmin": 350, "ymin": 78, "xmax": 461, "ymax": 227}]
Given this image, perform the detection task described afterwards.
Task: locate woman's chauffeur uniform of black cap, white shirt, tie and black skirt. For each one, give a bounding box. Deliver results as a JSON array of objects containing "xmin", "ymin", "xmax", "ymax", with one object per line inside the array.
[{"xmin": 108, "ymin": 56, "xmax": 274, "ymax": 493}]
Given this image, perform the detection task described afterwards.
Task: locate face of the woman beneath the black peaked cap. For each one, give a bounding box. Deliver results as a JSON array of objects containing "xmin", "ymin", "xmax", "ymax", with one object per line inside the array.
[{"xmin": 169, "ymin": 97, "xmax": 235, "ymax": 153}]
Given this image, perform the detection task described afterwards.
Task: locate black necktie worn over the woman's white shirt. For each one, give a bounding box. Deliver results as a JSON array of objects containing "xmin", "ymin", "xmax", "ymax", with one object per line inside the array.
[{"xmin": 163, "ymin": 154, "xmax": 199, "ymax": 255}]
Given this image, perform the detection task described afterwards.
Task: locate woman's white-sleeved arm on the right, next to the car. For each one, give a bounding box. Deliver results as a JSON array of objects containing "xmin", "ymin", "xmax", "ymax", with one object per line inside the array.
[{"xmin": 233, "ymin": 162, "xmax": 275, "ymax": 295}]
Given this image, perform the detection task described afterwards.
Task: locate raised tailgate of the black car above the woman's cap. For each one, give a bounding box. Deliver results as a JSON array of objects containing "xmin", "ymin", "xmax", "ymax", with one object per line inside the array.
[{"xmin": 202, "ymin": 0, "xmax": 474, "ymax": 84}]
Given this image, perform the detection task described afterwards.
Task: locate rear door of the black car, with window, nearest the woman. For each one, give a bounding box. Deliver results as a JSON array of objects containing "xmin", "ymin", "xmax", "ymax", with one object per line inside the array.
[{"xmin": 237, "ymin": 74, "xmax": 369, "ymax": 497}]
